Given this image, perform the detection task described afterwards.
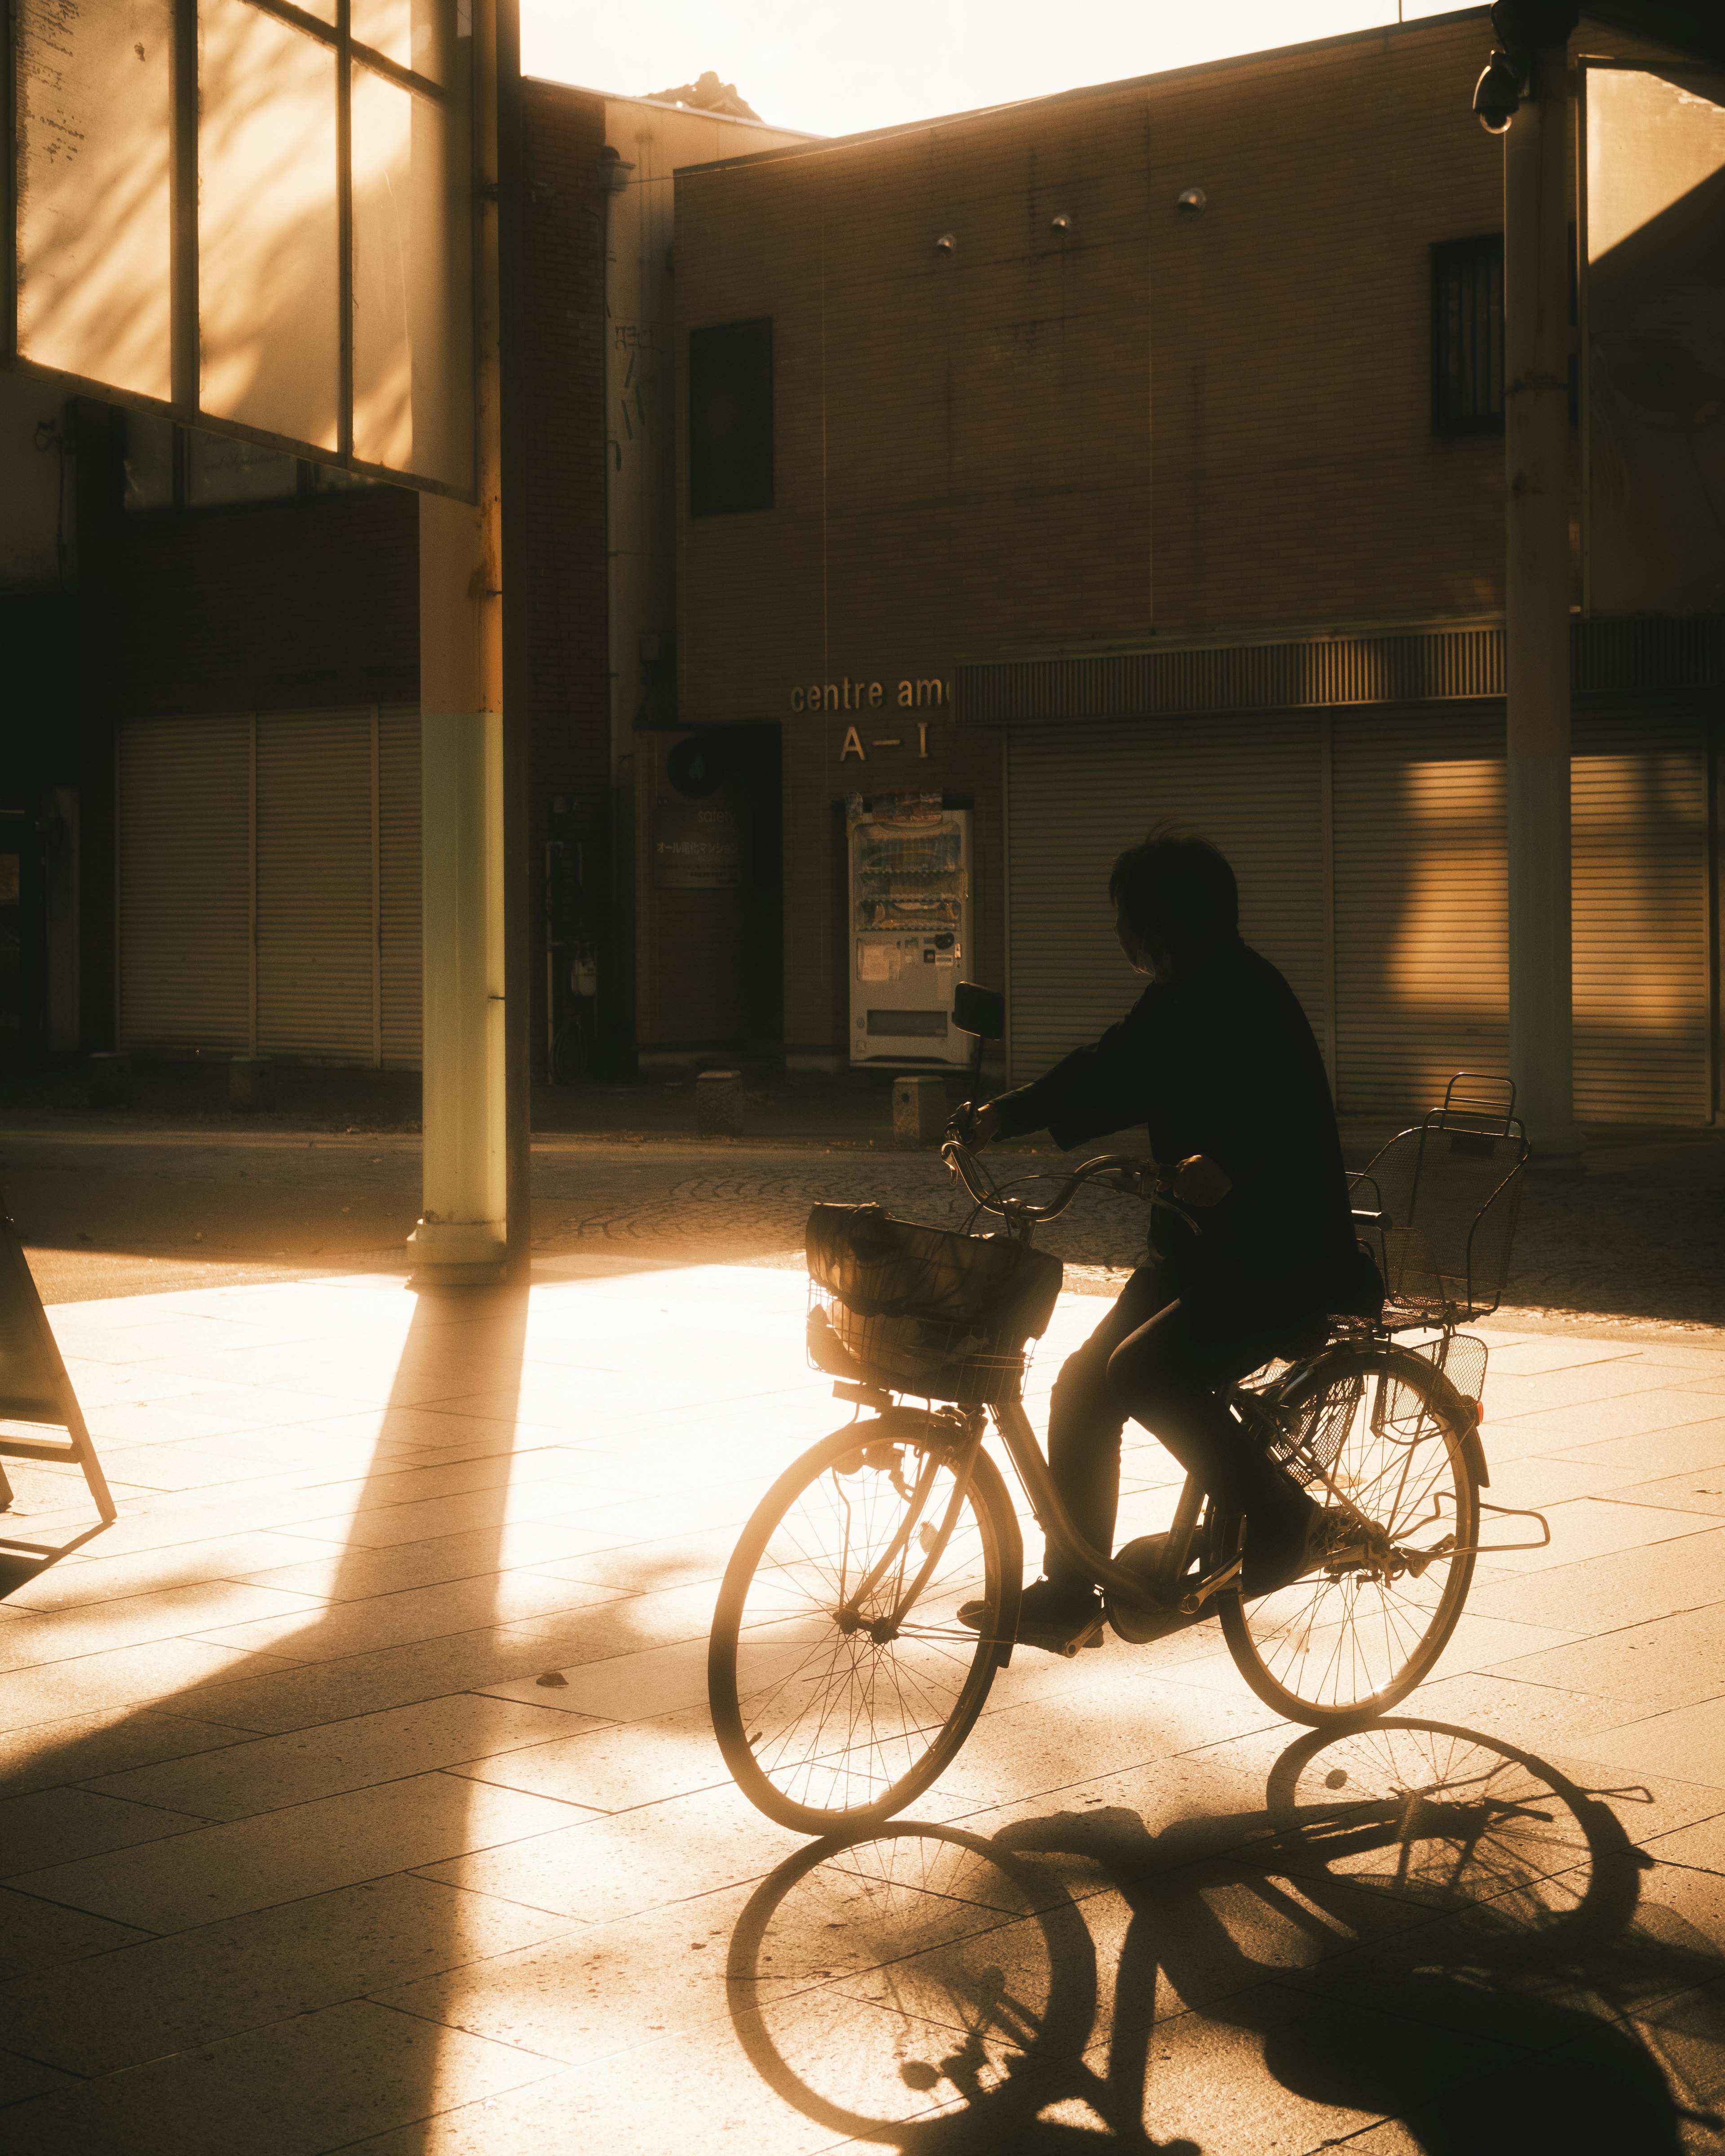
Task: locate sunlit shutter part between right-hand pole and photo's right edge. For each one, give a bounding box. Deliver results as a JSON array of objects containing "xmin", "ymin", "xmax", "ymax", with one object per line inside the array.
[{"xmin": 1572, "ymin": 709, "xmax": 1710, "ymax": 1123}]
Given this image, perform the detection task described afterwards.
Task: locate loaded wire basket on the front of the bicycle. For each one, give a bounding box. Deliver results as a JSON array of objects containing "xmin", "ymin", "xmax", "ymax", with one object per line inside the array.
[{"xmin": 806, "ymin": 1205, "xmax": 1063, "ymax": 1406}]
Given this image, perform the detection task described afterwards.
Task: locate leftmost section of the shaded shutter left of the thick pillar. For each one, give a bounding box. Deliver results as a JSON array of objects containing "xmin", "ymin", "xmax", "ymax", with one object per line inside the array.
[{"xmin": 116, "ymin": 716, "xmax": 252, "ymax": 1056}]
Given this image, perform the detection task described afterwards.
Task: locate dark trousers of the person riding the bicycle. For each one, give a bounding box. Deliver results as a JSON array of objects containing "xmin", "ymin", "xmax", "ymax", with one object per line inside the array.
[{"xmin": 1046, "ymin": 1266, "xmax": 1300, "ymax": 1585}]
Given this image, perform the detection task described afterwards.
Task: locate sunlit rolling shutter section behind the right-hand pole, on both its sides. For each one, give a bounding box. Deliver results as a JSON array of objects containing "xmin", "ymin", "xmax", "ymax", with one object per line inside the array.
[{"xmin": 1335, "ymin": 707, "xmax": 1708, "ymax": 1123}]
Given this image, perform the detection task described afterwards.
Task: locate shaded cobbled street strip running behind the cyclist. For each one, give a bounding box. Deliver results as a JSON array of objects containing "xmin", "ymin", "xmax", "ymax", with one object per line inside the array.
[{"xmin": 0, "ymin": 1130, "xmax": 1725, "ymax": 1328}]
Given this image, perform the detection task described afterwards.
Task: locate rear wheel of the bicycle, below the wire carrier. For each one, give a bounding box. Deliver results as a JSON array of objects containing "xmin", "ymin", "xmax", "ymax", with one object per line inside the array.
[{"xmin": 1221, "ymin": 1343, "xmax": 1479, "ymax": 1729}]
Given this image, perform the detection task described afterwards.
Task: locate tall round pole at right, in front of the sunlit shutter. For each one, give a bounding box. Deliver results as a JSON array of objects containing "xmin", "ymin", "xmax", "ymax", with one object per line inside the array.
[{"xmin": 1503, "ymin": 29, "xmax": 1580, "ymax": 1164}]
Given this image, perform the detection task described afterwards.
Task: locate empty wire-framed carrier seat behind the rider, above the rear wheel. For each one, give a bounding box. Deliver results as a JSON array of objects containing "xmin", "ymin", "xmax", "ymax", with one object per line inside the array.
[{"xmin": 1354, "ymin": 1072, "xmax": 1529, "ymax": 1326}]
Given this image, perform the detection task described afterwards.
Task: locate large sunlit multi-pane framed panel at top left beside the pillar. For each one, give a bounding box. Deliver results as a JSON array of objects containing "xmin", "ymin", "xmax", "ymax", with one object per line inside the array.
[{"xmin": 6, "ymin": 0, "xmax": 477, "ymax": 500}]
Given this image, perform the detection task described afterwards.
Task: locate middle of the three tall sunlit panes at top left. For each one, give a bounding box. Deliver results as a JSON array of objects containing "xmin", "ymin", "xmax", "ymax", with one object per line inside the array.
[{"xmin": 199, "ymin": 0, "xmax": 341, "ymax": 448}]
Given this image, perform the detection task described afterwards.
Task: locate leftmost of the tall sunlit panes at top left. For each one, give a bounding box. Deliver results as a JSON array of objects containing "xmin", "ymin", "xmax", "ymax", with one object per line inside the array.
[{"xmin": 15, "ymin": 0, "xmax": 172, "ymax": 401}]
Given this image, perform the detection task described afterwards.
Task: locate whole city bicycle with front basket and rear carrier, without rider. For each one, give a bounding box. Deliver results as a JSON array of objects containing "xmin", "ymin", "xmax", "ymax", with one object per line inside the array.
[{"xmin": 707, "ymin": 1074, "xmax": 1550, "ymax": 1835}]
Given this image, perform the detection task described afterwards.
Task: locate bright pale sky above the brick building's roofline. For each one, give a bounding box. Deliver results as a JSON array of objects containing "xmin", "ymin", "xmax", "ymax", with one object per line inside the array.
[{"xmin": 522, "ymin": 0, "xmax": 1483, "ymax": 134}]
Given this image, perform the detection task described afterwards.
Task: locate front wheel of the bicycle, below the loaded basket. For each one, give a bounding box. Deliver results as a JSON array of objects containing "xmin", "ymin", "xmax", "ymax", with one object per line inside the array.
[{"xmin": 707, "ymin": 1410, "xmax": 1016, "ymax": 1835}]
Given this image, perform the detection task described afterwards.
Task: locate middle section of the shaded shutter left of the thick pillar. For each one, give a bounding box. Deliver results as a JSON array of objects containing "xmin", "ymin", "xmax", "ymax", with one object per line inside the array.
[{"xmin": 257, "ymin": 709, "xmax": 377, "ymax": 1063}]
